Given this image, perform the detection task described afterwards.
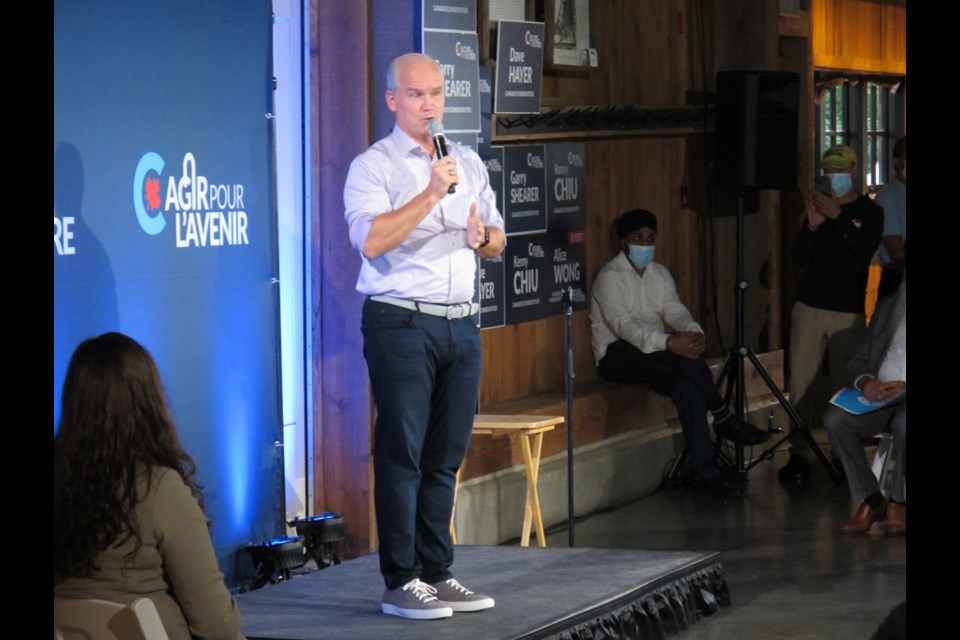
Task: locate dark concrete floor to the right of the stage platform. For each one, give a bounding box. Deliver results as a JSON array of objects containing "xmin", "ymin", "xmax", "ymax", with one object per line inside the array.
[{"xmin": 548, "ymin": 452, "xmax": 907, "ymax": 640}]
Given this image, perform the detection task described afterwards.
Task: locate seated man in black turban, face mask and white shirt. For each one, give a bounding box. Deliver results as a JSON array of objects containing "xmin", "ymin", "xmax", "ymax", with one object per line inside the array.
[{"xmin": 590, "ymin": 209, "xmax": 770, "ymax": 497}]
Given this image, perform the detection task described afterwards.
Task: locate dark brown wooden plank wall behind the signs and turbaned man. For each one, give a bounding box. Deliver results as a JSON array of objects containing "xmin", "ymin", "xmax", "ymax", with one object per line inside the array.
[{"xmin": 480, "ymin": 0, "xmax": 780, "ymax": 408}]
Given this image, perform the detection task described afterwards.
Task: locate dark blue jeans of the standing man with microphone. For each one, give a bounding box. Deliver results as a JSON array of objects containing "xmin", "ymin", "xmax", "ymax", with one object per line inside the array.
[{"xmin": 362, "ymin": 300, "xmax": 482, "ymax": 589}]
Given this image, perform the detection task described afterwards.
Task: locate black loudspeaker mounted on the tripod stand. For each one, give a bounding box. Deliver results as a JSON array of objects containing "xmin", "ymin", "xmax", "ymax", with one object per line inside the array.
[{"xmin": 715, "ymin": 71, "xmax": 800, "ymax": 189}]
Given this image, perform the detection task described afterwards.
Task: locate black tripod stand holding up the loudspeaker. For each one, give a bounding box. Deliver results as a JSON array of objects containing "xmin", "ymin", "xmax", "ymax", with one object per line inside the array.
[{"xmin": 717, "ymin": 191, "xmax": 841, "ymax": 485}]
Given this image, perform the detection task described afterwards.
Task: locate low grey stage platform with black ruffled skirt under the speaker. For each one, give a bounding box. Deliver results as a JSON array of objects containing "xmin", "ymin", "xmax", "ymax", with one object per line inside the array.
[{"xmin": 237, "ymin": 545, "xmax": 730, "ymax": 640}]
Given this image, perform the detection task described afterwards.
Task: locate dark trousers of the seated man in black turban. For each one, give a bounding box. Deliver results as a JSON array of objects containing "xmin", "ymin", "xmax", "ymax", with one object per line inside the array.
[{"xmin": 599, "ymin": 340, "xmax": 723, "ymax": 479}]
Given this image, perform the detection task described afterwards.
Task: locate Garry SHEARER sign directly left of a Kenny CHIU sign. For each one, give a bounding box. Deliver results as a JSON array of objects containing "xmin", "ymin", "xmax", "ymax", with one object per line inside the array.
[{"xmin": 502, "ymin": 144, "xmax": 547, "ymax": 235}]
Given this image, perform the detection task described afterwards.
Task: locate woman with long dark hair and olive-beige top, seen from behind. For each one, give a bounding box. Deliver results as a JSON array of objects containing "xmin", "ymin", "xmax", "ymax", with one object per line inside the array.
[{"xmin": 53, "ymin": 333, "xmax": 242, "ymax": 640}]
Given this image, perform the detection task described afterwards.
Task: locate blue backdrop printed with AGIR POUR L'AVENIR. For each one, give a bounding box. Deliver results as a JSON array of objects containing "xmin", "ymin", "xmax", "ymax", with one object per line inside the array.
[{"xmin": 53, "ymin": 0, "xmax": 283, "ymax": 586}]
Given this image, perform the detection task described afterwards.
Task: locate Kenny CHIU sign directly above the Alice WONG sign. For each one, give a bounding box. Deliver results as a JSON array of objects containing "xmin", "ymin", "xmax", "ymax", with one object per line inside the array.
[{"xmin": 546, "ymin": 142, "xmax": 587, "ymax": 233}]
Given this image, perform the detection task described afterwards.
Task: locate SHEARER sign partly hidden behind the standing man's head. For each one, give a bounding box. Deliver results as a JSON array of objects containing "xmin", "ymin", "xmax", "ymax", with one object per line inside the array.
[{"xmin": 423, "ymin": 31, "xmax": 480, "ymax": 132}]
